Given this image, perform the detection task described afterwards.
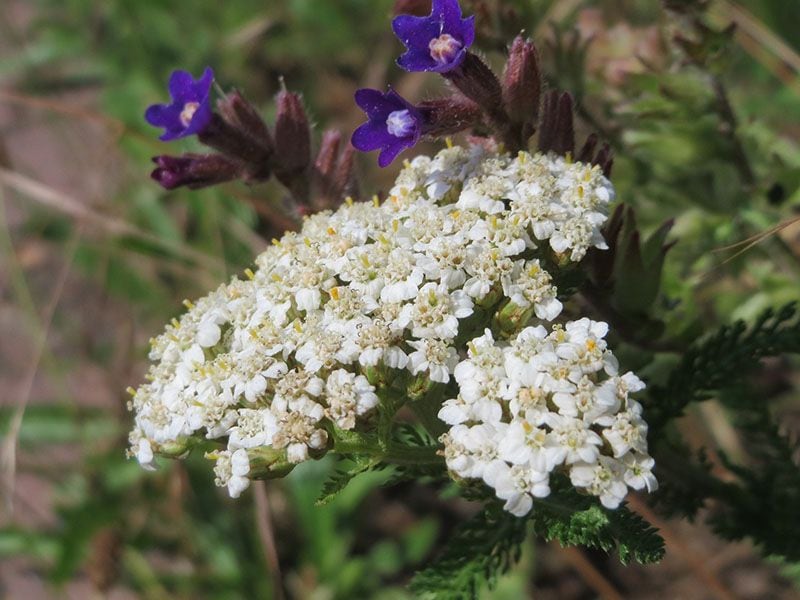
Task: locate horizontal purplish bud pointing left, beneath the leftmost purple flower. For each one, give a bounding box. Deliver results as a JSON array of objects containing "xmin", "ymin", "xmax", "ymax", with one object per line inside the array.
[{"xmin": 150, "ymin": 154, "xmax": 240, "ymax": 190}]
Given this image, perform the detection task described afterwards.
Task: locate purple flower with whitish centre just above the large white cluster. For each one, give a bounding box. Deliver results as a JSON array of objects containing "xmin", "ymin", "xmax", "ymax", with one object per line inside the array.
[{"xmin": 351, "ymin": 89, "xmax": 425, "ymax": 167}]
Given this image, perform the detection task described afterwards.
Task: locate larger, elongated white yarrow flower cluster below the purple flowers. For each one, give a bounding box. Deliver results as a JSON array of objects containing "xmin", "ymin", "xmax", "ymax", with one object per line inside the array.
[{"xmin": 130, "ymin": 146, "xmax": 613, "ymax": 504}]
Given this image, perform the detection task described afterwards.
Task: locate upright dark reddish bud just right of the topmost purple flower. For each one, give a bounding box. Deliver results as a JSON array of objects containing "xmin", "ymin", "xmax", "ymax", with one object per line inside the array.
[{"xmin": 503, "ymin": 36, "xmax": 542, "ymax": 139}]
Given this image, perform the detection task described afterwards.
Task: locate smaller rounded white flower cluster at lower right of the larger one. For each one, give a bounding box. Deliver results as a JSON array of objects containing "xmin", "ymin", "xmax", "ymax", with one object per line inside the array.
[{"xmin": 439, "ymin": 319, "xmax": 657, "ymax": 516}]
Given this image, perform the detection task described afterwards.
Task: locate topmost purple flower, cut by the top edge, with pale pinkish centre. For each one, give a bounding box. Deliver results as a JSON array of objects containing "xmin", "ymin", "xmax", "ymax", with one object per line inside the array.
[{"xmin": 392, "ymin": 0, "xmax": 475, "ymax": 73}]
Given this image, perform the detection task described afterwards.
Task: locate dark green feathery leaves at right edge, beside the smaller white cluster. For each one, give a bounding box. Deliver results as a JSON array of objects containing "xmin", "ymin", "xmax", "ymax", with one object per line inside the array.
[{"xmin": 648, "ymin": 304, "xmax": 800, "ymax": 561}]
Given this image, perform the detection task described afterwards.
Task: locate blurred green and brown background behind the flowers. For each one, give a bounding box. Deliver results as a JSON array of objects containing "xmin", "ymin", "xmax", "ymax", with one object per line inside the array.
[{"xmin": 0, "ymin": 0, "xmax": 800, "ymax": 599}]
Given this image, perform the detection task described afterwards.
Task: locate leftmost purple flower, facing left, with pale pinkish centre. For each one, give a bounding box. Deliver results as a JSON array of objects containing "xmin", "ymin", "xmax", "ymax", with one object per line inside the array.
[{"xmin": 144, "ymin": 67, "xmax": 214, "ymax": 142}]
